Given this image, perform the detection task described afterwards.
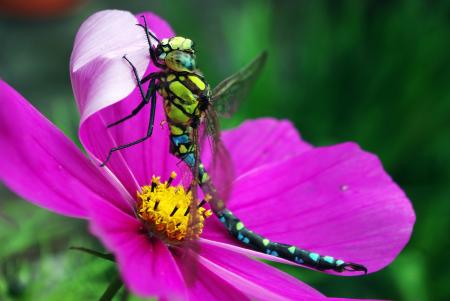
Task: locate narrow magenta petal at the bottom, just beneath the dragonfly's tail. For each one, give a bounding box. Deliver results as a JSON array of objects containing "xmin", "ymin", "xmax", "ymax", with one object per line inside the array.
[{"xmin": 198, "ymin": 244, "xmax": 325, "ymax": 300}]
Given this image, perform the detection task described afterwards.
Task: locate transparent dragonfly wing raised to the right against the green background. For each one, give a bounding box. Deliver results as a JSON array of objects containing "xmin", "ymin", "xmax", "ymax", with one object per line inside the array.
[{"xmin": 211, "ymin": 51, "xmax": 267, "ymax": 117}]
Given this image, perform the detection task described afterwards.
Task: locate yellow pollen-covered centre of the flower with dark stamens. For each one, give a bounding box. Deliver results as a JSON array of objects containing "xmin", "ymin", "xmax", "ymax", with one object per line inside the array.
[{"xmin": 137, "ymin": 172, "xmax": 212, "ymax": 244}]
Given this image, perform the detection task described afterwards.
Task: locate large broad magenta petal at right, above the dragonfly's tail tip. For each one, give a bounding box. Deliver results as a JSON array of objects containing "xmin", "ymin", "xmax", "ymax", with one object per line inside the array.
[{"xmin": 214, "ymin": 143, "xmax": 415, "ymax": 275}]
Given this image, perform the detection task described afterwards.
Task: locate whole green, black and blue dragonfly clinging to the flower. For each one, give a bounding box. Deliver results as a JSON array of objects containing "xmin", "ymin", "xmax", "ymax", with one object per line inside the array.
[{"xmin": 101, "ymin": 16, "xmax": 367, "ymax": 273}]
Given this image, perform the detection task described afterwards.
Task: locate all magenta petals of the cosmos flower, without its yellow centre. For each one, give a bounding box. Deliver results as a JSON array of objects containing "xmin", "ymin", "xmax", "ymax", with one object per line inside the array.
[{"xmin": 0, "ymin": 11, "xmax": 415, "ymax": 300}]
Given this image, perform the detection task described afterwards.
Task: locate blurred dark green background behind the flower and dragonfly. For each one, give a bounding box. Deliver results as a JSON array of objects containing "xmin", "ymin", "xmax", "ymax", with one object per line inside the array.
[{"xmin": 0, "ymin": 0, "xmax": 450, "ymax": 300}]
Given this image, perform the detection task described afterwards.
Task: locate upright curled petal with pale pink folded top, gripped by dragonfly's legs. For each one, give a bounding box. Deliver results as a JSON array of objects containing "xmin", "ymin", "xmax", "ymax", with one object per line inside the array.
[{"xmin": 71, "ymin": 11, "xmax": 178, "ymax": 194}]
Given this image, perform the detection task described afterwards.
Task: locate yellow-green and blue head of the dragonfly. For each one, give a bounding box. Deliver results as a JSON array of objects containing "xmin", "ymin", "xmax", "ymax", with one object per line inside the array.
[{"xmin": 155, "ymin": 37, "xmax": 195, "ymax": 72}]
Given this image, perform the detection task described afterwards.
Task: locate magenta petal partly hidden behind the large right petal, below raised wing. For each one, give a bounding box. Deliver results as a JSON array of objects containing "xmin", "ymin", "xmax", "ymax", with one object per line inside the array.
[{"xmin": 222, "ymin": 118, "xmax": 312, "ymax": 176}]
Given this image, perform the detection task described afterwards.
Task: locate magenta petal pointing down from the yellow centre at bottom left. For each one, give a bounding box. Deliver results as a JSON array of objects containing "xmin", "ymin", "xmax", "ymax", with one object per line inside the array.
[{"xmin": 89, "ymin": 197, "xmax": 186, "ymax": 300}]
